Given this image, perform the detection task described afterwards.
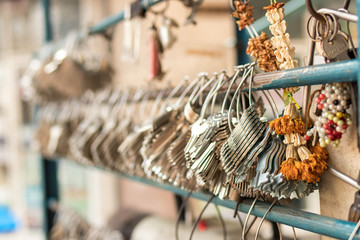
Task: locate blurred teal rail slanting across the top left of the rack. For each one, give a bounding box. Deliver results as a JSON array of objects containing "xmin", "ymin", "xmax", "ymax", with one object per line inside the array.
[{"xmin": 89, "ymin": 0, "xmax": 164, "ymax": 34}]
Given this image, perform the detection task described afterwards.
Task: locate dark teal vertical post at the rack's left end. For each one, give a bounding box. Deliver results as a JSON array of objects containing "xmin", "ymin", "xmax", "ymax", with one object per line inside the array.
[{"xmin": 41, "ymin": 0, "xmax": 59, "ymax": 239}]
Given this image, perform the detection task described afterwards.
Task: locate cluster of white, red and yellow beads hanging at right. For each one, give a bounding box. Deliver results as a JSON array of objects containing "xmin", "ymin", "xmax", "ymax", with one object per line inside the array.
[{"xmin": 305, "ymin": 83, "xmax": 352, "ymax": 147}]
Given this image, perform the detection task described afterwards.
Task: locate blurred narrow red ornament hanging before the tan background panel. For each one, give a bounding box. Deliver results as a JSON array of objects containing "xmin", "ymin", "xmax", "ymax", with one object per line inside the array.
[{"xmin": 148, "ymin": 23, "xmax": 164, "ymax": 81}]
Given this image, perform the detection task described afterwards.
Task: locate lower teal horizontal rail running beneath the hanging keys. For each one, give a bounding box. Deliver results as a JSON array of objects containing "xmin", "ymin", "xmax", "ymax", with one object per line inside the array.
[{"xmin": 59, "ymin": 158, "xmax": 360, "ymax": 239}]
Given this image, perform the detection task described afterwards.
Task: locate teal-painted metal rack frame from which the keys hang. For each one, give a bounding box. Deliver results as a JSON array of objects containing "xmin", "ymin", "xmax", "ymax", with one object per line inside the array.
[{"xmin": 42, "ymin": 0, "xmax": 360, "ymax": 239}]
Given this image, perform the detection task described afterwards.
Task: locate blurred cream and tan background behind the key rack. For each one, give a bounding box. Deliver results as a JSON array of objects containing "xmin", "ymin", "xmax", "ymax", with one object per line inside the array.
[{"xmin": 0, "ymin": 0, "xmax": 357, "ymax": 240}]
